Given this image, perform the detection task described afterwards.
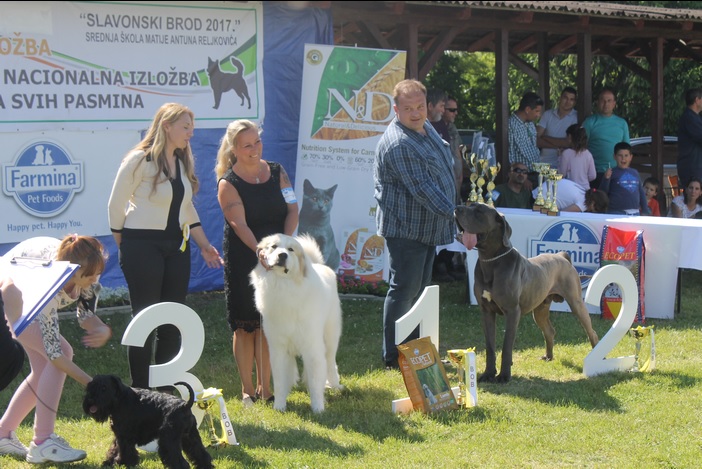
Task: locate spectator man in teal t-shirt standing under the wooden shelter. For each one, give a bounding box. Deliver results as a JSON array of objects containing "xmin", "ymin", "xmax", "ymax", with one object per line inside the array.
[{"xmin": 583, "ymin": 88, "xmax": 629, "ymax": 187}]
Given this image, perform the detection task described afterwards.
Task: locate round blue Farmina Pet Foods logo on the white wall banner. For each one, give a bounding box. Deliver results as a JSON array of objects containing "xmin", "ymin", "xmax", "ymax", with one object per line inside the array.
[{"xmin": 2, "ymin": 140, "xmax": 83, "ymax": 218}]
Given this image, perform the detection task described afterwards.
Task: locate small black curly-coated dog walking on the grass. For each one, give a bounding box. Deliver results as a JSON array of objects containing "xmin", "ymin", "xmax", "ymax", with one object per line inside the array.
[{"xmin": 83, "ymin": 375, "xmax": 214, "ymax": 469}]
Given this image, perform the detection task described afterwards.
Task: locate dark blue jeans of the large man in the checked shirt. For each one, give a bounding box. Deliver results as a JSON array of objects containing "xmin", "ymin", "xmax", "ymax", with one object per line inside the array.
[{"xmin": 383, "ymin": 238, "xmax": 436, "ymax": 363}]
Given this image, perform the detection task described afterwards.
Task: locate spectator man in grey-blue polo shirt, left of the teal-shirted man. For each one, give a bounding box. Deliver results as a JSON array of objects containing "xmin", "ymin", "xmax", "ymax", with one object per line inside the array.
[{"xmin": 508, "ymin": 92, "xmax": 544, "ymax": 190}]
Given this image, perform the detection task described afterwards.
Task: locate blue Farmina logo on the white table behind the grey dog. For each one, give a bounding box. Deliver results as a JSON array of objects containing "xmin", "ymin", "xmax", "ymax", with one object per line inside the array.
[{"xmin": 529, "ymin": 220, "xmax": 600, "ymax": 290}]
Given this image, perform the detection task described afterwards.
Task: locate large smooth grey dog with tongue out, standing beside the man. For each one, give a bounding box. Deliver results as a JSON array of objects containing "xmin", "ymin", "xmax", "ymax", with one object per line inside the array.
[{"xmin": 455, "ymin": 204, "xmax": 598, "ymax": 383}]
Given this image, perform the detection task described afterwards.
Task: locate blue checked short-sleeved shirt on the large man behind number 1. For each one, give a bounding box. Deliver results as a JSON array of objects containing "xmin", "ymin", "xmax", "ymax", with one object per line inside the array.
[{"xmin": 373, "ymin": 118, "xmax": 456, "ymax": 246}]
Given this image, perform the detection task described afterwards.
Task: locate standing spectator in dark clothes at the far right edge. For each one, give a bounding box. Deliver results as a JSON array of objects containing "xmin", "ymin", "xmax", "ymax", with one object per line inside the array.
[{"xmin": 678, "ymin": 88, "xmax": 702, "ymax": 187}]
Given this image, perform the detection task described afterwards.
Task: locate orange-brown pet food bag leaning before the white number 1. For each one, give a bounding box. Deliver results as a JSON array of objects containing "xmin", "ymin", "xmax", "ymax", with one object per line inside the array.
[{"xmin": 397, "ymin": 337, "xmax": 458, "ymax": 413}]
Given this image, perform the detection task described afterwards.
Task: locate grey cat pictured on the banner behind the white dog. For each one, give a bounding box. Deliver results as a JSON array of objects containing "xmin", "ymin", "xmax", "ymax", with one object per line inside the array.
[{"xmin": 297, "ymin": 179, "xmax": 341, "ymax": 272}]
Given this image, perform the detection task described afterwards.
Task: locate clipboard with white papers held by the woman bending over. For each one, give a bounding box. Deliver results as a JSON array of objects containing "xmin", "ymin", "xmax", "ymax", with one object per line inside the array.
[{"xmin": 0, "ymin": 255, "xmax": 80, "ymax": 336}]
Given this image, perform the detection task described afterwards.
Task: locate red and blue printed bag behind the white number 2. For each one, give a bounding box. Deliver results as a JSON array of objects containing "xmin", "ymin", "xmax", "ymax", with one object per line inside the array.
[{"xmin": 600, "ymin": 225, "xmax": 646, "ymax": 324}]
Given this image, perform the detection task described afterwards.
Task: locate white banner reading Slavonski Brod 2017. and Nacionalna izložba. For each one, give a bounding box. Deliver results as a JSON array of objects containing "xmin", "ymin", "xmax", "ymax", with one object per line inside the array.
[{"xmin": 0, "ymin": 2, "xmax": 264, "ymax": 132}]
